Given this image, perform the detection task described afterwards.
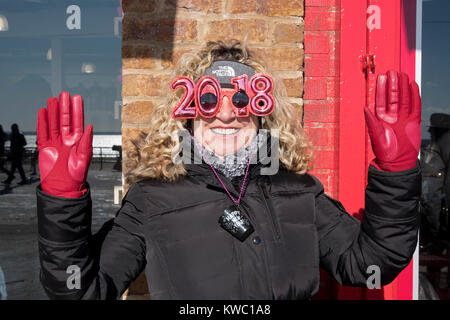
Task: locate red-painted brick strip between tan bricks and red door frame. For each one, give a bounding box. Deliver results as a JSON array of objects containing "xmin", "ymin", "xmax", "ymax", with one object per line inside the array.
[{"xmin": 303, "ymin": 0, "xmax": 340, "ymax": 300}]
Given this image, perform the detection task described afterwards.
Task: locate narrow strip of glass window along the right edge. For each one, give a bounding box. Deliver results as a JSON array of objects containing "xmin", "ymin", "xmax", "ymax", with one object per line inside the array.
[{"xmin": 419, "ymin": 0, "xmax": 450, "ymax": 300}]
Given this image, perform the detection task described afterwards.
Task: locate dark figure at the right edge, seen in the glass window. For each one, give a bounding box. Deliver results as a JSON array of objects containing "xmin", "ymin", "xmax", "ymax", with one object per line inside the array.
[{"xmin": 421, "ymin": 113, "xmax": 450, "ymax": 249}]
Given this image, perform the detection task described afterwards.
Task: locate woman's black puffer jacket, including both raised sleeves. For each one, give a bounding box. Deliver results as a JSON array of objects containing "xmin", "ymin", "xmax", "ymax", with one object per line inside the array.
[{"xmin": 37, "ymin": 165, "xmax": 421, "ymax": 299}]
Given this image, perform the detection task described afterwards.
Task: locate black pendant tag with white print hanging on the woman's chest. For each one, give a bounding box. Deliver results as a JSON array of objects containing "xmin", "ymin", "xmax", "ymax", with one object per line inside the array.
[{"xmin": 219, "ymin": 205, "xmax": 255, "ymax": 242}]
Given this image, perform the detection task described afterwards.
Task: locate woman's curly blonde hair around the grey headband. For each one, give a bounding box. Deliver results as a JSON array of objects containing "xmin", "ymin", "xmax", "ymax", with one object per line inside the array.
[{"xmin": 125, "ymin": 40, "xmax": 312, "ymax": 184}]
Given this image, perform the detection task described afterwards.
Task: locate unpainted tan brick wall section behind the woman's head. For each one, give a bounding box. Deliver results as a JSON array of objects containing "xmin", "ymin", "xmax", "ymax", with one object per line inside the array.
[{"xmin": 122, "ymin": 0, "xmax": 306, "ymax": 300}]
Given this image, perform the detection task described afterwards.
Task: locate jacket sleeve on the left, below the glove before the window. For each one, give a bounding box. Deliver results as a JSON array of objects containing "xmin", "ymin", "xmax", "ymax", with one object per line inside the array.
[{"xmin": 37, "ymin": 184, "xmax": 146, "ymax": 299}]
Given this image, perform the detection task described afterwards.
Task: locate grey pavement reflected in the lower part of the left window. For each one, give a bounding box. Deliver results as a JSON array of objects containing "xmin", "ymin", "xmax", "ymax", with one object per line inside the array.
[{"xmin": 0, "ymin": 163, "xmax": 122, "ymax": 300}]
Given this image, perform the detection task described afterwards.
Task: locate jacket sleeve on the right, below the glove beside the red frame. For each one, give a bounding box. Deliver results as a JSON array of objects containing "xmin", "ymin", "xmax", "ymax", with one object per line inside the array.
[{"xmin": 316, "ymin": 165, "xmax": 421, "ymax": 286}]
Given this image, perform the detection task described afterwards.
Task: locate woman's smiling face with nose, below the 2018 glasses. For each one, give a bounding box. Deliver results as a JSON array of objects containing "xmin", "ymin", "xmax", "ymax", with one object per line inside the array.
[{"xmin": 194, "ymin": 89, "xmax": 258, "ymax": 157}]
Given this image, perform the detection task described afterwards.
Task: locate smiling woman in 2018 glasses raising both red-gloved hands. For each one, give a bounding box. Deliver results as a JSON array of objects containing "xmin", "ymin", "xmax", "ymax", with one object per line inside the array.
[{"xmin": 37, "ymin": 42, "xmax": 420, "ymax": 299}]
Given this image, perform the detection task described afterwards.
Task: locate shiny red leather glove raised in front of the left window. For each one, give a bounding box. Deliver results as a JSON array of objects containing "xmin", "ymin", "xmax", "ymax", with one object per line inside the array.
[{"xmin": 37, "ymin": 91, "xmax": 92, "ymax": 198}]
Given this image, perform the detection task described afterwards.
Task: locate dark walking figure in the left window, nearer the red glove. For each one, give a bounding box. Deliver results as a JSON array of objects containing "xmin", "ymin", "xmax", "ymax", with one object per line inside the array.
[{"xmin": 3, "ymin": 123, "xmax": 28, "ymax": 184}]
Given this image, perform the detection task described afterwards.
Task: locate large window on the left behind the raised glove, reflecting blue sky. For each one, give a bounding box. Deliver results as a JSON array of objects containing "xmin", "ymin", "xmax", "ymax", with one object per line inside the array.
[{"xmin": 0, "ymin": 0, "xmax": 122, "ymax": 299}]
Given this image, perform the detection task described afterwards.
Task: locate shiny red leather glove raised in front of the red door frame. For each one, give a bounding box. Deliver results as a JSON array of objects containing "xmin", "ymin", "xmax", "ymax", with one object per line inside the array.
[{"xmin": 364, "ymin": 70, "xmax": 422, "ymax": 171}]
